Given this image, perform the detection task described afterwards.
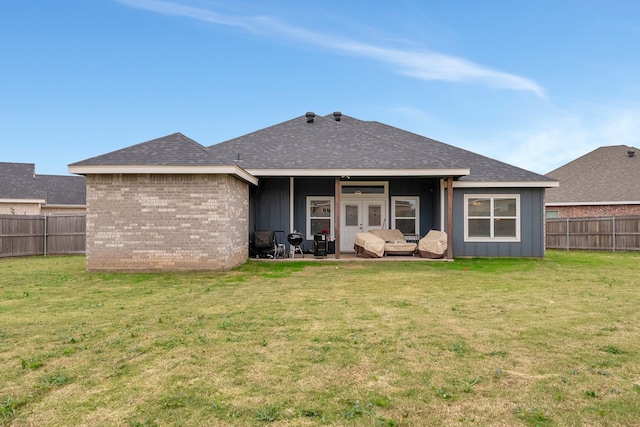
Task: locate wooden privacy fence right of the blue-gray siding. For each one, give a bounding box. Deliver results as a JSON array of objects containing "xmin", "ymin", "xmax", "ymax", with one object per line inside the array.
[{"xmin": 546, "ymin": 216, "xmax": 640, "ymax": 252}]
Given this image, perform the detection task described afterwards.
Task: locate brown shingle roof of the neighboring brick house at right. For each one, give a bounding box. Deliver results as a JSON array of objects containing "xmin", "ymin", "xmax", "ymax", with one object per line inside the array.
[{"xmin": 546, "ymin": 145, "xmax": 640, "ymax": 205}]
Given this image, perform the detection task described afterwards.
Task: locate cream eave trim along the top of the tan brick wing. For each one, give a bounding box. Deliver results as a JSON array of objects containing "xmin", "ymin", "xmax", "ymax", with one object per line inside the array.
[{"xmin": 69, "ymin": 165, "xmax": 258, "ymax": 185}]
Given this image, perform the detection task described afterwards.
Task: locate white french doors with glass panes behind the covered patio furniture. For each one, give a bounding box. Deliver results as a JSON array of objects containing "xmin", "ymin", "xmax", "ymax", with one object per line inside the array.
[{"xmin": 340, "ymin": 199, "xmax": 387, "ymax": 252}]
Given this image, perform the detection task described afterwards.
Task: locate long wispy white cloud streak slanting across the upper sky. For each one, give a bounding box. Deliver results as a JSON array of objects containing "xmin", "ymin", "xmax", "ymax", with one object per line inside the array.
[{"xmin": 117, "ymin": 0, "xmax": 544, "ymax": 97}]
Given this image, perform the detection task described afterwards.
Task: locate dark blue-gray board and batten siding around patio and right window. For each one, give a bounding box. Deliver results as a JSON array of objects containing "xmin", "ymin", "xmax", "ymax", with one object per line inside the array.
[{"xmin": 250, "ymin": 177, "xmax": 545, "ymax": 257}]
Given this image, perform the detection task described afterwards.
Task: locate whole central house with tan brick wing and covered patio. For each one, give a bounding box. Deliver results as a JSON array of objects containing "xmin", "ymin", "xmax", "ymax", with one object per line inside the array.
[{"xmin": 69, "ymin": 113, "xmax": 558, "ymax": 270}]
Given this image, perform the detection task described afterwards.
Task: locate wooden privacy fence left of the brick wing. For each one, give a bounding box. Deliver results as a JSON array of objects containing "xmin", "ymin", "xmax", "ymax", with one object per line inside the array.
[{"xmin": 0, "ymin": 214, "xmax": 86, "ymax": 257}]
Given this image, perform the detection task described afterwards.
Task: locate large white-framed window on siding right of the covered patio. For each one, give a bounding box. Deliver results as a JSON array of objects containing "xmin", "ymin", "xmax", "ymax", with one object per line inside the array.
[{"xmin": 464, "ymin": 194, "xmax": 520, "ymax": 242}]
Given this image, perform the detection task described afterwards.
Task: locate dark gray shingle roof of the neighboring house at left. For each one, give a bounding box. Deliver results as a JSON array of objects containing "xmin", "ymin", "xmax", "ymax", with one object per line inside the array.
[{"xmin": 0, "ymin": 162, "xmax": 86, "ymax": 206}]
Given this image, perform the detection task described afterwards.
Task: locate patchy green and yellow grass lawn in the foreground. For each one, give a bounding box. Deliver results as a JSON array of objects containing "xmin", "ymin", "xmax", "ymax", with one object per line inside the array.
[{"xmin": 0, "ymin": 251, "xmax": 640, "ymax": 426}]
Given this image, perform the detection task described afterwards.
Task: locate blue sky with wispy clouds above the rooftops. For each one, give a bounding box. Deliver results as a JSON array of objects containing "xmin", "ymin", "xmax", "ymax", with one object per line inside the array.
[{"xmin": 0, "ymin": 0, "xmax": 640, "ymax": 174}]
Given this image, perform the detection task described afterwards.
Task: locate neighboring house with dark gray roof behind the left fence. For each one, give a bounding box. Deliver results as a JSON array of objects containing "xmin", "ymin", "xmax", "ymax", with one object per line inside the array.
[{"xmin": 0, "ymin": 162, "xmax": 86, "ymax": 215}]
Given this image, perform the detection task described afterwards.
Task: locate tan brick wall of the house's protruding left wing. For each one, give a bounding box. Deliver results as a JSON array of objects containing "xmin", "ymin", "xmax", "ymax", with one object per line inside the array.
[{"xmin": 87, "ymin": 174, "xmax": 249, "ymax": 271}]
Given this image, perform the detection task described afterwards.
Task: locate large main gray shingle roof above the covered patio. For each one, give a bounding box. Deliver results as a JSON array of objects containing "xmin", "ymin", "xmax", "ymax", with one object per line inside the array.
[{"xmin": 209, "ymin": 111, "xmax": 553, "ymax": 182}]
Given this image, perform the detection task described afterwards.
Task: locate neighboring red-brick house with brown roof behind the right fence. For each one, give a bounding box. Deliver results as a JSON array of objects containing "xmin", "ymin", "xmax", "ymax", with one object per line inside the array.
[{"xmin": 546, "ymin": 145, "xmax": 640, "ymax": 218}]
